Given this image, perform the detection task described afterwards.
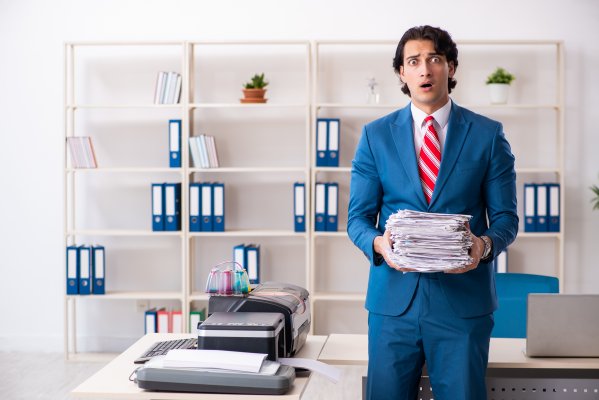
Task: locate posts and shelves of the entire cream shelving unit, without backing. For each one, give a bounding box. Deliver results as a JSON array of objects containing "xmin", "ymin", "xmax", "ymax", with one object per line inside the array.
[{"xmin": 63, "ymin": 40, "xmax": 565, "ymax": 358}]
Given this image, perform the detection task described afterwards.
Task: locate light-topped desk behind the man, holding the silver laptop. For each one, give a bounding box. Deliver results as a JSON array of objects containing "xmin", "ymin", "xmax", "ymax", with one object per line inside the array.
[{"xmin": 318, "ymin": 334, "xmax": 599, "ymax": 400}]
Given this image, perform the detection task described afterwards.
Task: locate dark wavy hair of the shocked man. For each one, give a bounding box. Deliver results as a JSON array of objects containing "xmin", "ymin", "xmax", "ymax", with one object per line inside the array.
[{"xmin": 393, "ymin": 25, "xmax": 458, "ymax": 96}]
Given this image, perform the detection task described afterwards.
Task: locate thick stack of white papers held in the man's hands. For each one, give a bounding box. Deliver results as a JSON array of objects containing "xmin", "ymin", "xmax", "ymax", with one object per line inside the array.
[{"xmin": 385, "ymin": 210, "xmax": 473, "ymax": 272}]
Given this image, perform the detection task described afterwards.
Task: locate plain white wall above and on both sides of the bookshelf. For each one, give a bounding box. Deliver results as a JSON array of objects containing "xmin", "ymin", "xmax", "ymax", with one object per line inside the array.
[{"xmin": 0, "ymin": 0, "xmax": 599, "ymax": 351}]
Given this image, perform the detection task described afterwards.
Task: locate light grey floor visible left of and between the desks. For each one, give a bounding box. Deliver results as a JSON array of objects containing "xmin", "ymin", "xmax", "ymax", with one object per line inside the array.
[{"xmin": 0, "ymin": 353, "xmax": 366, "ymax": 400}]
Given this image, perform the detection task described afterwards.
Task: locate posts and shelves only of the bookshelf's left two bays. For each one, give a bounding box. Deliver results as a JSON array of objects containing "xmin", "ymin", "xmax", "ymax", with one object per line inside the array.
[{"xmin": 63, "ymin": 41, "xmax": 311, "ymax": 359}]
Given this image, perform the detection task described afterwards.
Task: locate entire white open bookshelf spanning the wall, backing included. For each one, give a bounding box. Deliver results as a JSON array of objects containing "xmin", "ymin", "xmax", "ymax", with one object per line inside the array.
[{"xmin": 64, "ymin": 40, "xmax": 565, "ymax": 357}]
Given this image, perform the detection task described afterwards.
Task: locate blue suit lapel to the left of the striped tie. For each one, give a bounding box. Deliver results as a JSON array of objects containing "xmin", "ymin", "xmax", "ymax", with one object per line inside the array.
[{"xmin": 391, "ymin": 105, "xmax": 428, "ymax": 210}]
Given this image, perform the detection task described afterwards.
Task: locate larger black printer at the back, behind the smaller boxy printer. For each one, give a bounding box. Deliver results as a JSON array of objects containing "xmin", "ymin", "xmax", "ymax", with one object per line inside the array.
[{"xmin": 208, "ymin": 282, "xmax": 311, "ymax": 357}]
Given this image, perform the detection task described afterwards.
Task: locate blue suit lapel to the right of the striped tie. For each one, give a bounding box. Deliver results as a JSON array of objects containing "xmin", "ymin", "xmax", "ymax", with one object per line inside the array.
[{"xmin": 430, "ymin": 102, "xmax": 470, "ymax": 206}]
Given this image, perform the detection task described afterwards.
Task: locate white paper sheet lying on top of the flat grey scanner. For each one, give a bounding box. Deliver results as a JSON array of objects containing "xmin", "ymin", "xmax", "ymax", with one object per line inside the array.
[{"xmin": 164, "ymin": 349, "xmax": 267, "ymax": 372}]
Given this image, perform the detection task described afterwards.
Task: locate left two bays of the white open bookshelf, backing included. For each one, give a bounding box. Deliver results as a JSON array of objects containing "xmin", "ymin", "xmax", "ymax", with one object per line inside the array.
[{"xmin": 64, "ymin": 41, "xmax": 311, "ymax": 358}]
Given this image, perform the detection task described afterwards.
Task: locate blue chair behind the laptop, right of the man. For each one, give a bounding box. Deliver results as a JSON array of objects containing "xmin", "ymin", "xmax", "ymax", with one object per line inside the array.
[{"xmin": 491, "ymin": 272, "xmax": 559, "ymax": 338}]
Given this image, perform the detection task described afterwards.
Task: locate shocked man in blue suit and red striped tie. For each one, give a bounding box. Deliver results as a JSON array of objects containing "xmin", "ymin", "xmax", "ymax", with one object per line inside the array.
[{"xmin": 347, "ymin": 26, "xmax": 518, "ymax": 400}]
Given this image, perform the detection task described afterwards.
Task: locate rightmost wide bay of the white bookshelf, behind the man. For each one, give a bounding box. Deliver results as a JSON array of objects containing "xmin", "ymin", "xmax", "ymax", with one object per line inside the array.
[{"xmin": 310, "ymin": 40, "xmax": 565, "ymax": 333}]
